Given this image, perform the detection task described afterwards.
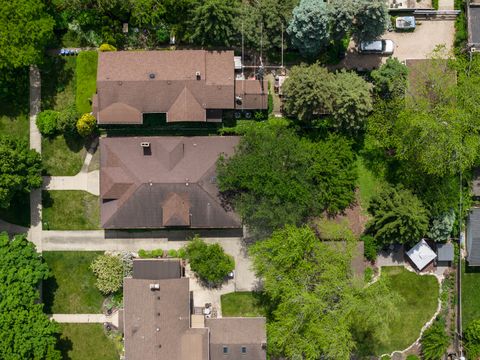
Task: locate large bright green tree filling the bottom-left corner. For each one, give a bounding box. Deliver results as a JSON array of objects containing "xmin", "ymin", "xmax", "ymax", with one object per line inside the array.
[{"xmin": 0, "ymin": 233, "xmax": 61, "ymax": 360}]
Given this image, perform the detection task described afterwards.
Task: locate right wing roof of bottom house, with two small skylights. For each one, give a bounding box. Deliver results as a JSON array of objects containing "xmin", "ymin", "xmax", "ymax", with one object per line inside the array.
[{"xmin": 205, "ymin": 317, "xmax": 267, "ymax": 360}]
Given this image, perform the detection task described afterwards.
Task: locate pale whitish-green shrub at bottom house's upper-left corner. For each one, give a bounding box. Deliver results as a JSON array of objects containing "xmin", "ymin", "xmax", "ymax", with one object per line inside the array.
[{"xmin": 90, "ymin": 255, "xmax": 124, "ymax": 295}]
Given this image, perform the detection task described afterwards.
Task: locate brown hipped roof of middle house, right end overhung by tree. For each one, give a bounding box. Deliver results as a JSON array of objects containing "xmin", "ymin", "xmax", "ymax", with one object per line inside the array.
[{"xmin": 100, "ymin": 136, "xmax": 241, "ymax": 229}]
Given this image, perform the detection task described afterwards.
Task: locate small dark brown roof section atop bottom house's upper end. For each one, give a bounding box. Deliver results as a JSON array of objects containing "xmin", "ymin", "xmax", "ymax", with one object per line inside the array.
[{"xmin": 133, "ymin": 259, "xmax": 182, "ymax": 280}]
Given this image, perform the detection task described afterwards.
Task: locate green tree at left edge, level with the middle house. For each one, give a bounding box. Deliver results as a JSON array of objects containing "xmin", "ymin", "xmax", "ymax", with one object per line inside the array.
[{"xmin": 0, "ymin": 136, "xmax": 42, "ymax": 208}]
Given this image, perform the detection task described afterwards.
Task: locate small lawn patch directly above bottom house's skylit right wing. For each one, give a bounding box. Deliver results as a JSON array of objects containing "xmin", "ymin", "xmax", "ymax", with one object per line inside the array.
[{"xmin": 221, "ymin": 291, "xmax": 265, "ymax": 317}]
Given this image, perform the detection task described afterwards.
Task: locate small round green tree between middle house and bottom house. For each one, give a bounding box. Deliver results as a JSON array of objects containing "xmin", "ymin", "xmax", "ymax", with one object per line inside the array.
[{"xmin": 185, "ymin": 237, "xmax": 235, "ymax": 286}]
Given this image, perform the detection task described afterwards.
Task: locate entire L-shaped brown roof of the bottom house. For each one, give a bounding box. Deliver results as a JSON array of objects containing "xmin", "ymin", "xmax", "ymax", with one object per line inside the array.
[{"xmin": 123, "ymin": 259, "xmax": 266, "ymax": 360}]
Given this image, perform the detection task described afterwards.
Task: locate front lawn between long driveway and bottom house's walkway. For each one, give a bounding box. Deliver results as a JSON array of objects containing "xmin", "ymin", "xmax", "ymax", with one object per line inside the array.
[{"xmin": 42, "ymin": 251, "xmax": 103, "ymax": 314}]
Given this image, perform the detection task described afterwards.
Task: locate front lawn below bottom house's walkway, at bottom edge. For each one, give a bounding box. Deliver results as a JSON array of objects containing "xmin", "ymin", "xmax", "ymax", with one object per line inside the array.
[{"xmin": 58, "ymin": 324, "xmax": 119, "ymax": 360}]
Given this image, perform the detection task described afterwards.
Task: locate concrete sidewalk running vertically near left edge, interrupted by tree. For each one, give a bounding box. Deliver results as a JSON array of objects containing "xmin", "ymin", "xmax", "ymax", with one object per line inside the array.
[{"xmin": 28, "ymin": 65, "xmax": 42, "ymax": 252}]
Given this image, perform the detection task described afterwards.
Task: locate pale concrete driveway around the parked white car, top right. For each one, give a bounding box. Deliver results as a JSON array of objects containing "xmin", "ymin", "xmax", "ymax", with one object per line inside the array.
[{"xmin": 339, "ymin": 20, "xmax": 455, "ymax": 69}]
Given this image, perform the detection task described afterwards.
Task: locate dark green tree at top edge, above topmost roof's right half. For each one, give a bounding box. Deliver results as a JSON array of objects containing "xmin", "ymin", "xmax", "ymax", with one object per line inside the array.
[{"xmin": 191, "ymin": 0, "xmax": 240, "ymax": 46}]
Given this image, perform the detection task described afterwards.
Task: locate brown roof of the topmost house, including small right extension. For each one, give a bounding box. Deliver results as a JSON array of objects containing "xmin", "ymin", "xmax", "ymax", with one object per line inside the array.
[{"xmin": 92, "ymin": 50, "xmax": 268, "ymax": 125}]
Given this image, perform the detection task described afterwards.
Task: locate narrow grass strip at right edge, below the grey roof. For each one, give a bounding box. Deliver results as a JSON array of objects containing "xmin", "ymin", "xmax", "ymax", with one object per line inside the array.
[{"xmin": 462, "ymin": 261, "xmax": 480, "ymax": 329}]
